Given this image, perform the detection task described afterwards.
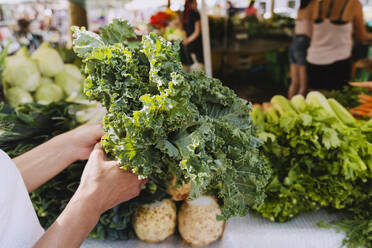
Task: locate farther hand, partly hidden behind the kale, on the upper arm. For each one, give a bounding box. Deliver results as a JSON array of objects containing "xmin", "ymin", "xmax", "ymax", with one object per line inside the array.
[{"xmin": 60, "ymin": 124, "xmax": 104, "ymax": 160}]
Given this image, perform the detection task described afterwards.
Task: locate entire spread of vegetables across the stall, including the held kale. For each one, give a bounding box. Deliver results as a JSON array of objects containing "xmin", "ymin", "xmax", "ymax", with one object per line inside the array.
[{"xmin": 0, "ymin": 15, "xmax": 372, "ymax": 248}]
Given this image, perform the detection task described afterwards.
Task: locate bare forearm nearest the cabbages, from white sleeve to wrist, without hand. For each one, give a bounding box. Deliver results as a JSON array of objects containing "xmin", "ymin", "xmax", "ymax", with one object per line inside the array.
[{"xmin": 13, "ymin": 134, "xmax": 77, "ymax": 192}]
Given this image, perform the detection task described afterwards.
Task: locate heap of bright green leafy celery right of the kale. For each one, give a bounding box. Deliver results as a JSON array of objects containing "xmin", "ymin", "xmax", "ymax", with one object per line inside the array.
[{"xmin": 252, "ymin": 92, "xmax": 372, "ymax": 247}]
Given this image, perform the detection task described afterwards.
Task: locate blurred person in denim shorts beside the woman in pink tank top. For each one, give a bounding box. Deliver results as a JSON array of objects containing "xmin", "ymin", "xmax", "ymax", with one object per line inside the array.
[{"xmin": 288, "ymin": 0, "xmax": 313, "ymax": 98}]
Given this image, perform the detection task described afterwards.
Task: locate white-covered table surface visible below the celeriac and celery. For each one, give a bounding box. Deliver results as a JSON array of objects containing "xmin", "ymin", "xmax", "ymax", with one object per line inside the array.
[{"xmin": 82, "ymin": 211, "xmax": 345, "ymax": 248}]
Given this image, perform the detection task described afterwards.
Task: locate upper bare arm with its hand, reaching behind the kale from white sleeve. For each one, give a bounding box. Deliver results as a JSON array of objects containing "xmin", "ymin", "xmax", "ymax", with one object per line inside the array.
[{"xmin": 13, "ymin": 125, "xmax": 103, "ymax": 192}]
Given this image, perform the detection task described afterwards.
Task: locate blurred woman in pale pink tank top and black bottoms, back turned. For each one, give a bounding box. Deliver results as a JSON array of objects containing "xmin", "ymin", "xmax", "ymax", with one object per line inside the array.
[{"xmin": 307, "ymin": 0, "xmax": 372, "ymax": 90}]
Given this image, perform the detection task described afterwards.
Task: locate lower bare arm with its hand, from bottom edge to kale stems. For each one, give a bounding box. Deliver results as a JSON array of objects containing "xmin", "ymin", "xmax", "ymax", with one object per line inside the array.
[{"xmin": 34, "ymin": 145, "xmax": 144, "ymax": 248}]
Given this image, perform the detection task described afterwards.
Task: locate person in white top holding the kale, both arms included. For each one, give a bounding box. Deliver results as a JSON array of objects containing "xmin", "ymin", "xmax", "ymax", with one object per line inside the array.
[{"xmin": 0, "ymin": 125, "xmax": 145, "ymax": 248}]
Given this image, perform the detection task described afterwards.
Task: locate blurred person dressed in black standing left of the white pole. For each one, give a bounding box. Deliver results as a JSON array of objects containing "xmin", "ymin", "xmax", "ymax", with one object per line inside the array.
[{"xmin": 182, "ymin": 0, "xmax": 204, "ymax": 65}]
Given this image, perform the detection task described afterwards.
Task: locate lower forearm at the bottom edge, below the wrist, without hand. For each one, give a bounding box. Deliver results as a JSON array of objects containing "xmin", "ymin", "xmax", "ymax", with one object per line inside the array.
[{"xmin": 34, "ymin": 192, "xmax": 100, "ymax": 248}]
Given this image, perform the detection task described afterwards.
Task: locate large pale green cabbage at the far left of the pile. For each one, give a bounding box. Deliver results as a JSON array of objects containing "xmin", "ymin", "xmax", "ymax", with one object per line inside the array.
[{"xmin": 2, "ymin": 53, "xmax": 40, "ymax": 91}]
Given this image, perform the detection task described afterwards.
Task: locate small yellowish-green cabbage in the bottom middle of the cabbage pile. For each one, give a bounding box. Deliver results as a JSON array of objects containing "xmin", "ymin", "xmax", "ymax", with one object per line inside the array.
[{"xmin": 35, "ymin": 83, "xmax": 63, "ymax": 104}]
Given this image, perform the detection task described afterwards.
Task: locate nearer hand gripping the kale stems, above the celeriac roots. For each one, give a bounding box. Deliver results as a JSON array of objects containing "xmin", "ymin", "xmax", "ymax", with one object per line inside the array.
[{"xmin": 76, "ymin": 144, "xmax": 146, "ymax": 215}]
